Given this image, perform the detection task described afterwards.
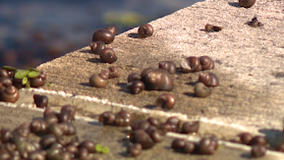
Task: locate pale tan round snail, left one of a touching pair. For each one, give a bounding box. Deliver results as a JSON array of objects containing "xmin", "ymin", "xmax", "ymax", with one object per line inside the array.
[{"xmin": 89, "ymin": 70, "xmax": 109, "ymax": 88}]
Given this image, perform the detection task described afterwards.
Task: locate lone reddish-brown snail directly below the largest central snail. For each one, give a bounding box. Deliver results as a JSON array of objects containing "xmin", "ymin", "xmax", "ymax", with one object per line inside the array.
[{"xmin": 156, "ymin": 93, "xmax": 175, "ymax": 109}]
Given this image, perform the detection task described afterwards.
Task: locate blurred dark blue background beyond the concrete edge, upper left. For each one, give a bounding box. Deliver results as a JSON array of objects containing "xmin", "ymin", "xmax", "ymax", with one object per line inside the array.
[{"xmin": 0, "ymin": 0, "xmax": 203, "ymax": 69}]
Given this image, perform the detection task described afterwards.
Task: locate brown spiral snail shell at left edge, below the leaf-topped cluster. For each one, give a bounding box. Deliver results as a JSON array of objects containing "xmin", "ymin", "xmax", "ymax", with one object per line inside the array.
[{"xmin": 1, "ymin": 85, "xmax": 19, "ymax": 103}]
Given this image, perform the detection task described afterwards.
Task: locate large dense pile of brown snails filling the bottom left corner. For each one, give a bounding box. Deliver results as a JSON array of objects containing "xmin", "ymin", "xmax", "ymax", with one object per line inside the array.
[{"xmin": 0, "ymin": 105, "xmax": 109, "ymax": 160}]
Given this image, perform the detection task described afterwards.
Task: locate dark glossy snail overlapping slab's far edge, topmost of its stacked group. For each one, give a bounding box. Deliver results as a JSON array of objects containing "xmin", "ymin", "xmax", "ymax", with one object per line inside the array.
[{"xmin": 92, "ymin": 29, "xmax": 114, "ymax": 44}]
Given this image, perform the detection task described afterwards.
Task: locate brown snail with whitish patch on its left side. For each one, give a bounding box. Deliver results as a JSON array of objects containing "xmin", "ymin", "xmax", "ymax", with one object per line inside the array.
[{"xmin": 180, "ymin": 56, "xmax": 202, "ymax": 73}]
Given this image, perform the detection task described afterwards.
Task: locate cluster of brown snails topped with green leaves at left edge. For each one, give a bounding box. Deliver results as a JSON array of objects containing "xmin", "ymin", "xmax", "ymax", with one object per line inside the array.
[{"xmin": 0, "ymin": 66, "xmax": 46, "ymax": 103}]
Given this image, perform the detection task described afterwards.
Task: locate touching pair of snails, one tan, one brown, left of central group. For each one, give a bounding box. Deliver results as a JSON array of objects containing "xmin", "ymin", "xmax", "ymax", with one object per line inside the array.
[{"xmin": 89, "ymin": 66, "xmax": 119, "ymax": 88}]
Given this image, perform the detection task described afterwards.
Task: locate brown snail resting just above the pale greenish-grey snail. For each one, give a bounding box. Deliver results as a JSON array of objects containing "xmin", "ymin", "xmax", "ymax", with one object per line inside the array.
[{"xmin": 198, "ymin": 72, "xmax": 219, "ymax": 87}]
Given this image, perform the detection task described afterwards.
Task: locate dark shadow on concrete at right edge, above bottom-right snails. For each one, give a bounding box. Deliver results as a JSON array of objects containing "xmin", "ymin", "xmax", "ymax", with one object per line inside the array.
[{"xmin": 258, "ymin": 129, "xmax": 283, "ymax": 149}]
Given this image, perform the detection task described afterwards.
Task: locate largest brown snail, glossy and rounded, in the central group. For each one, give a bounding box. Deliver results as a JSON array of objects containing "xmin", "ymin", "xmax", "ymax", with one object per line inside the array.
[{"xmin": 141, "ymin": 67, "xmax": 174, "ymax": 91}]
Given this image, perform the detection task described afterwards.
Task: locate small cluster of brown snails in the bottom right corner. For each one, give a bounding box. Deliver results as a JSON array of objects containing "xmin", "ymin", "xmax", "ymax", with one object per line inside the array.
[{"xmin": 232, "ymin": 132, "xmax": 268, "ymax": 157}]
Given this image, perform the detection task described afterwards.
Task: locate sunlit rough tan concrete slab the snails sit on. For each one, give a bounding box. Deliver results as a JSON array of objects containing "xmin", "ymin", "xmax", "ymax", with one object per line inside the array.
[{"xmin": 0, "ymin": 0, "xmax": 284, "ymax": 160}]
